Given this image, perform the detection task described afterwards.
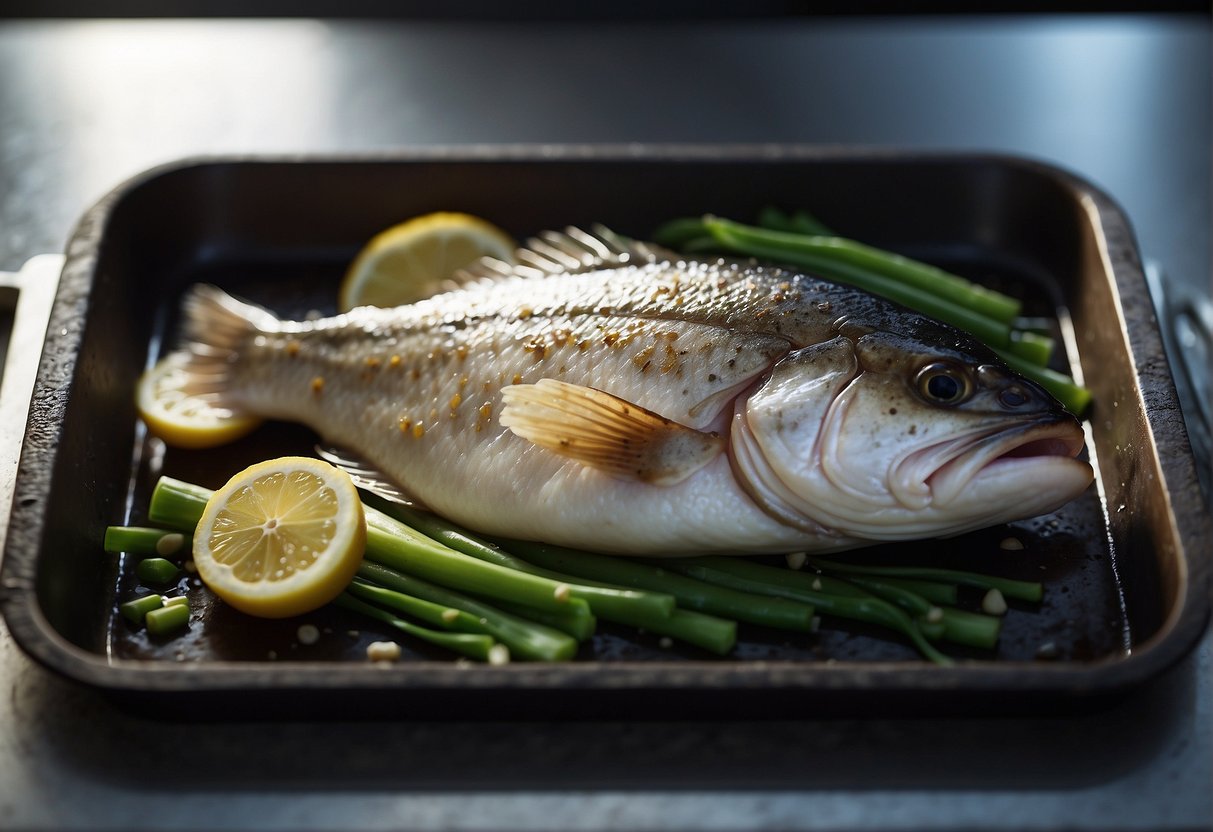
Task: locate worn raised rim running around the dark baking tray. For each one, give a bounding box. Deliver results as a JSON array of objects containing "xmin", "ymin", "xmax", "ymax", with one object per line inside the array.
[{"xmin": 0, "ymin": 144, "xmax": 1213, "ymax": 713}]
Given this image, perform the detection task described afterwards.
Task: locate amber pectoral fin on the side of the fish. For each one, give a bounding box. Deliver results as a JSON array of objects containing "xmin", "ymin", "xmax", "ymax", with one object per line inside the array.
[{"xmin": 500, "ymin": 378, "xmax": 725, "ymax": 485}]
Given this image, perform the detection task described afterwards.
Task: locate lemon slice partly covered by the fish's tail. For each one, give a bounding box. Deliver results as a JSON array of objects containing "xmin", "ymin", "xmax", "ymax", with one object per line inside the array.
[{"xmin": 135, "ymin": 353, "xmax": 261, "ymax": 448}]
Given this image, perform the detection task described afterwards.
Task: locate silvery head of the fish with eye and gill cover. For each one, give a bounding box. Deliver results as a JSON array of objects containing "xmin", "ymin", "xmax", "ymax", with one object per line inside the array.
[{"xmin": 731, "ymin": 320, "xmax": 1093, "ymax": 548}]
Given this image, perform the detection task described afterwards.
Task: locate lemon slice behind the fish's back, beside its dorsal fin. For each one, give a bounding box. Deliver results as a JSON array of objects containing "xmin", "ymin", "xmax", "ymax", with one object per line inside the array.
[{"xmin": 337, "ymin": 211, "xmax": 514, "ymax": 312}]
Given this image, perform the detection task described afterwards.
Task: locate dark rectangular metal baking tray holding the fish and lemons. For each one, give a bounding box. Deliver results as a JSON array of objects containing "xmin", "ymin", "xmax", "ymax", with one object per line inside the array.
[{"xmin": 0, "ymin": 147, "xmax": 1209, "ymax": 718}]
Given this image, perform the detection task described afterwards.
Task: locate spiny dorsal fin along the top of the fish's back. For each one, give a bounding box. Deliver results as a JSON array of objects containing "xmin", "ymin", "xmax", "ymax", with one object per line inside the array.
[{"xmin": 451, "ymin": 226, "xmax": 677, "ymax": 286}]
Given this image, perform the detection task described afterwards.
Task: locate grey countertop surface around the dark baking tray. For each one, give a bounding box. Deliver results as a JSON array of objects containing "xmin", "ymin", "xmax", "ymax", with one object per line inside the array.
[{"xmin": 0, "ymin": 16, "xmax": 1213, "ymax": 830}]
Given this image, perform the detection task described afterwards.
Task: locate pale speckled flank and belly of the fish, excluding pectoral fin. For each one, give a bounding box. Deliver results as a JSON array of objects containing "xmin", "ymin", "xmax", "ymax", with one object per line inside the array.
[{"xmin": 218, "ymin": 299, "xmax": 837, "ymax": 555}]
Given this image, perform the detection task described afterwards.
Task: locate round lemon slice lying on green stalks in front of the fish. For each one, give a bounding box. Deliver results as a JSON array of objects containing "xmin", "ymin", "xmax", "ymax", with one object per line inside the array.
[{"xmin": 194, "ymin": 456, "xmax": 366, "ymax": 619}]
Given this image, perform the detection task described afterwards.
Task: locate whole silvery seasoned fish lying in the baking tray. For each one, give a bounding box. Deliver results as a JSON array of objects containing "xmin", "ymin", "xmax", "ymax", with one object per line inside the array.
[{"xmin": 175, "ymin": 229, "xmax": 1093, "ymax": 555}]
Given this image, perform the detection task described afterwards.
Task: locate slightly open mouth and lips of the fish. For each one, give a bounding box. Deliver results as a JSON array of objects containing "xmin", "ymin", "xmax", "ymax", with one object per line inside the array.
[{"xmin": 912, "ymin": 417, "xmax": 1094, "ymax": 513}]
